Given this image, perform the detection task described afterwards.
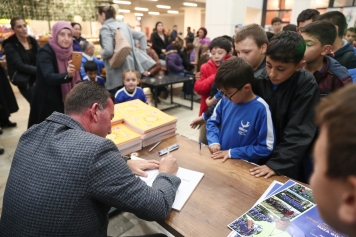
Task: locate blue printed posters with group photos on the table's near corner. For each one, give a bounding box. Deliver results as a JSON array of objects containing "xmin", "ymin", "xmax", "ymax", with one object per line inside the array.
[{"xmin": 228, "ymin": 180, "xmax": 346, "ymax": 237}]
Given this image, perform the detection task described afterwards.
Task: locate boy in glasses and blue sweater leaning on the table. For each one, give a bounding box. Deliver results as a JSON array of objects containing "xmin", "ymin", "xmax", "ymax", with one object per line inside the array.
[{"xmin": 206, "ymin": 57, "xmax": 274, "ymax": 162}]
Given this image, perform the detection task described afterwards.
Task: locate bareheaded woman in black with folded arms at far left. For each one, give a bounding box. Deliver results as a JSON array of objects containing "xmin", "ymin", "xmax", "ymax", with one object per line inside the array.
[{"xmin": 2, "ymin": 17, "xmax": 40, "ymax": 104}]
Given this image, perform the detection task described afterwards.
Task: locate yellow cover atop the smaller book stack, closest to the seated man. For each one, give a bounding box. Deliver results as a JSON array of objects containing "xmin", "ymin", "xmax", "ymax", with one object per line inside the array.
[{"xmin": 106, "ymin": 123, "xmax": 141, "ymax": 145}]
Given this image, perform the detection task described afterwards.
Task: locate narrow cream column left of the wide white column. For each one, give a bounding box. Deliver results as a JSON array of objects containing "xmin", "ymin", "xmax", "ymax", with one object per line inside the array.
[{"xmin": 185, "ymin": 7, "xmax": 202, "ymax": 38}]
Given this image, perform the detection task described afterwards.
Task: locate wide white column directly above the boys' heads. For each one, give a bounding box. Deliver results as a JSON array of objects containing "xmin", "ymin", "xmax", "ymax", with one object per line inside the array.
[{"xmin": 205, "ymin": 0, "xmax": 247, "ymax": 39}]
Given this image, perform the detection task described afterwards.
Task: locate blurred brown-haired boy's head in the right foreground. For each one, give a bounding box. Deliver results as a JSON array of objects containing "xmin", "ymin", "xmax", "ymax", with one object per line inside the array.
[{"xmin": 310, "ymin": 85, "xmax": 356, "ymax": 236}]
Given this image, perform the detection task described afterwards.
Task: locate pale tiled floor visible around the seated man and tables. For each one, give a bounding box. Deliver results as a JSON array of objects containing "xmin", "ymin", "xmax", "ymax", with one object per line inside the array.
[{"xmin": 0, "ymin": 83, "xmax": 199, "ymax": 237}]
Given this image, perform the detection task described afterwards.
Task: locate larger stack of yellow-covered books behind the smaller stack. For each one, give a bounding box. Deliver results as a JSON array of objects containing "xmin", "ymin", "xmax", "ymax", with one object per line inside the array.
[{"xmin": 107, "ymin": 100, "xmax": 177, "ymax": 155}]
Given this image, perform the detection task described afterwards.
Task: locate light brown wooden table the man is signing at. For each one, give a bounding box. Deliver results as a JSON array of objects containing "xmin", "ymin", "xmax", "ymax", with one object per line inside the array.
[{"xmin": 139, "ymin": 135, "xmax": 288, "ymax": 237}]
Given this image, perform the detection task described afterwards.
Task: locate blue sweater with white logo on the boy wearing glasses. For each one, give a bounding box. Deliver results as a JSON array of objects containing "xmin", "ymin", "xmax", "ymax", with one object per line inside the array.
[{"xmin": 206, "ymin": 96, "xmax": 275, "ymax": 161}]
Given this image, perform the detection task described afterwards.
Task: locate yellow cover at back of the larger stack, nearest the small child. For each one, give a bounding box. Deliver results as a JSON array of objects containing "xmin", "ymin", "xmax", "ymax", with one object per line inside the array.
[{"xmin": 115, "ymin": 99, "xmax": 153, "ymax": 118}]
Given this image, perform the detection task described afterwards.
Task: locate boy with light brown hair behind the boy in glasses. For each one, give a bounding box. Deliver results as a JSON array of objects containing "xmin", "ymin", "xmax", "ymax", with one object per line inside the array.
[{"xmin": 190, "ymin": 24, "xmax": 268, "ymax": 128}]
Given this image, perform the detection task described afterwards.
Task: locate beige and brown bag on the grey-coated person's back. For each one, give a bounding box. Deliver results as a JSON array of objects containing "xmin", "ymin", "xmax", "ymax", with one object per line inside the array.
[{"xmin": 109, "ymin": 28, "xmax": 132, "ymax": 68}]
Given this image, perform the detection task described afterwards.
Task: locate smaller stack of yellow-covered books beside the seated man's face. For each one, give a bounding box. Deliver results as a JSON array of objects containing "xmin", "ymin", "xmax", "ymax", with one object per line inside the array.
[{"xmin": 106, "ymin": 123, "xmax": 142, "ymax": 155}]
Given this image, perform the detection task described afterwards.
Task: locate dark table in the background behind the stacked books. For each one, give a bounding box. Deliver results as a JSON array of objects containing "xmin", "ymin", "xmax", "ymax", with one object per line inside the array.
[{"xmin": 141, "ymin": 75, "xmax": 194, "ymax": 110}]
